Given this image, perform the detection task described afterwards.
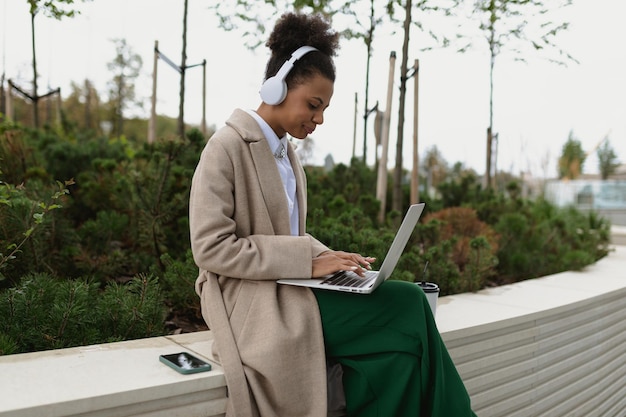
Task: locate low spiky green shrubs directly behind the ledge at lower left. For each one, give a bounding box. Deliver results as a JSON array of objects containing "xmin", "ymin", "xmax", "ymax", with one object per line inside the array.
[{"xmin": 0, "ymin": 273, "xmax": 165, "ymax": 353}]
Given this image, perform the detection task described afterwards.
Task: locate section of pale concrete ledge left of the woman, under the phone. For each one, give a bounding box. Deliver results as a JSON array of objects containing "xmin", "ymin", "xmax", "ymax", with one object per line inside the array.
[{"xmin": 0, "ymin": 334, "xmax": 227, "ymax": 417}]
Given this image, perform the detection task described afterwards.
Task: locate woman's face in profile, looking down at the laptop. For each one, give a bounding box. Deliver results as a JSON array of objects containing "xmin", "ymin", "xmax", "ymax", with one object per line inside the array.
[{"xmin": 269, "ymin": 74, "xmax": 334, "ymax": 139}]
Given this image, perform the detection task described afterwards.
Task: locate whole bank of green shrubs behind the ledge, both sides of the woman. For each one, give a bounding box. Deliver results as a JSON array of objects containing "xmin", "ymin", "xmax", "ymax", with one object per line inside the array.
[{"xmin": 0, "ymin": 122, "xmax": 610, "ymax": 354}]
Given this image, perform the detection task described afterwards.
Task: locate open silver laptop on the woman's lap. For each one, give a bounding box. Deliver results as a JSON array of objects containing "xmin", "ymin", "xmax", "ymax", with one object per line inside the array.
[{"xmin": 277, "ymin": 203, "xmax": 424, "ymax": 294}]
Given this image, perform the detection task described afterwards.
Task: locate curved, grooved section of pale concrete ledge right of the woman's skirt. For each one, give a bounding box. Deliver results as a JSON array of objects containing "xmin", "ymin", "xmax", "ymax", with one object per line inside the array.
[{"xmin": 437, "ymin": 246, "xmax": 626, "ymax": 417}]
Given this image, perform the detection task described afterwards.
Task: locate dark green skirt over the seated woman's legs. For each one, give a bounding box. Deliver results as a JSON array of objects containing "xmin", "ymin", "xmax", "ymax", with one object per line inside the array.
[{"xmin": 314, "ymin": 280, "xmax": 475, "ymax": 417}]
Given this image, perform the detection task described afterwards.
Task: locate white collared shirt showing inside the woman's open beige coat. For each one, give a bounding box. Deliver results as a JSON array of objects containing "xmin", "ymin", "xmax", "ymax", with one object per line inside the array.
[{"xmin": 246, "ymin": 110, "xmax": 300, "ymax": 236}]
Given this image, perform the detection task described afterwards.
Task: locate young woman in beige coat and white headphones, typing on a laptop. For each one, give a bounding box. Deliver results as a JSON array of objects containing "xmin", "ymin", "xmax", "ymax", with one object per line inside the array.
[{"xmin": 190, "ymin": 13, "xmax": 474, "ymax": 417}]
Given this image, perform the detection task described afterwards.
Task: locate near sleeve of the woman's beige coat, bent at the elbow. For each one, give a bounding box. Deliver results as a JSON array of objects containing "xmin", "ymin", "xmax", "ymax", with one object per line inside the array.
[{"xmin": 189, "ymin": 132, "xmax": 325, "ymax": 280}]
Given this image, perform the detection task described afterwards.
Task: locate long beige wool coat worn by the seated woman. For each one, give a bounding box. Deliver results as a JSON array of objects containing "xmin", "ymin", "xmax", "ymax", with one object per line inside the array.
[{"xmin": 189, "ymin": 110, "xmax": 328, "ymax": 417}]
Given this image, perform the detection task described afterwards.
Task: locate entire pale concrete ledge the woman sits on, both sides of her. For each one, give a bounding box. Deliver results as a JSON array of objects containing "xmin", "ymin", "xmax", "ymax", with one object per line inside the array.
[{"xmin": 0, "ymin": 246, "xmax": 626, "ymax": 417}]
